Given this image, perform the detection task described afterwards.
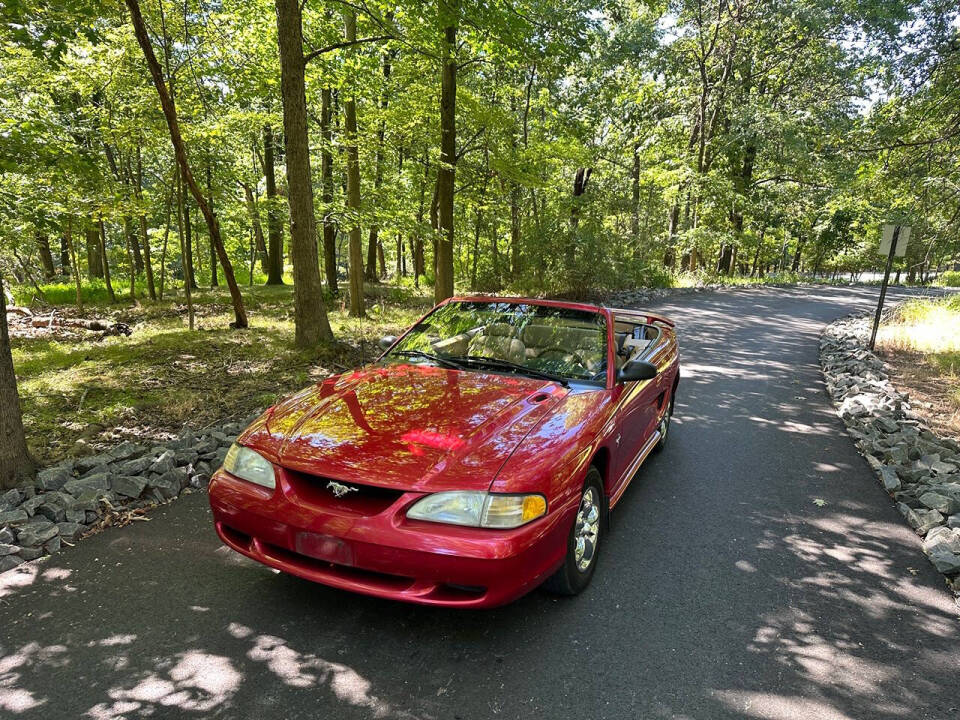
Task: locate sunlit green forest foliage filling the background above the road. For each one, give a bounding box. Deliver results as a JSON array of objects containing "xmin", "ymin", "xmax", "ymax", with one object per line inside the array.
[{"xmin": 0, "ymin": 0, "xmax": 960, "ymax": 316}]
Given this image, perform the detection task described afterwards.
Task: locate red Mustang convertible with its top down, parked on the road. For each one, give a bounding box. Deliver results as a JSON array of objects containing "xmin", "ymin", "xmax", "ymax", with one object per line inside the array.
[{"xmin": 210, "ymin": 297, "xmax": 679, "ymax": 607}]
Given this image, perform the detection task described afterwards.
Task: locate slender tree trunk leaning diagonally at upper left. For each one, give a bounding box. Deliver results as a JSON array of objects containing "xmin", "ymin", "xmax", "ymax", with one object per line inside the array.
[{"xmin": 126, "ymin": 0, "xmax": 247, "ymax": 328}]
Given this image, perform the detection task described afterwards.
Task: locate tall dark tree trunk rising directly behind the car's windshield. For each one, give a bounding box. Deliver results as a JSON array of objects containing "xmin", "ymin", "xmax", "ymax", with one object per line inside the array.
[{"xmin": 433, "ymin": 7, "xmax": 459, "ymax": 302}]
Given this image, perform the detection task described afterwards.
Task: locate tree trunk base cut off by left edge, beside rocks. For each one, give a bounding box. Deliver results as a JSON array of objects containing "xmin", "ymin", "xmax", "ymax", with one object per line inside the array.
[{"xmin": 0, "ymin": 276, "xmax": 37, "ymax": 490}]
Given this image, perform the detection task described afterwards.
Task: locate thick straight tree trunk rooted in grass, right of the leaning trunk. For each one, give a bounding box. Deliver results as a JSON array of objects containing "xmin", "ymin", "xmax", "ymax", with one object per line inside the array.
[{"xmin": 276, "ymin": 0, "xmax": 333, "ymax": 347}]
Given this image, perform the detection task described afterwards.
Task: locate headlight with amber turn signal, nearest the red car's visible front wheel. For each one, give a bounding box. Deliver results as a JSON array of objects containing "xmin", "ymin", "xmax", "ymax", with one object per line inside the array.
[{"xmin": 407, "ymin": 492, "xmax": 547, "ymax": 528}]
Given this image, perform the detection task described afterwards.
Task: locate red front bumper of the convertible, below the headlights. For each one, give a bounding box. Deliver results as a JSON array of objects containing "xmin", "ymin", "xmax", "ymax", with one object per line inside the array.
[{"xmin": 210, "ymin": 468, "xmax": 573, "ymax": 607}]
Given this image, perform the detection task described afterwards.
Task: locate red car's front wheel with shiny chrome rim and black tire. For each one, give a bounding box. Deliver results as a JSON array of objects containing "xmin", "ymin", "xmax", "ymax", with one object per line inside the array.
[{"xmin": 544, "ymin": 467, "xmax": 606, "ymax": 595}]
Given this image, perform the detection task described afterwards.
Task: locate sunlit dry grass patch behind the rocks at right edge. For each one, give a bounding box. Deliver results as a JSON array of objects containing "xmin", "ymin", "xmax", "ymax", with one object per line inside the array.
[{"xmin": 877, "ymin": 295, "xmax": 960, "ymax": 440}]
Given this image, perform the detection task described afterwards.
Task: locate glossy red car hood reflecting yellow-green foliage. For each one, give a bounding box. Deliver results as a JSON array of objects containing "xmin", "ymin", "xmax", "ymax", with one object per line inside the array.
[{"xmin": 239, "ymin": 363, "xmax": 568, "ymax": 492}]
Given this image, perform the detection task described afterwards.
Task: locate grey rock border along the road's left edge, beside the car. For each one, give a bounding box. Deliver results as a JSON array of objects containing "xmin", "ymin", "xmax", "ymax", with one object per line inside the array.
[{"xmin": 0, "ymin": 418, "xmax": 254, "ymax": 572}]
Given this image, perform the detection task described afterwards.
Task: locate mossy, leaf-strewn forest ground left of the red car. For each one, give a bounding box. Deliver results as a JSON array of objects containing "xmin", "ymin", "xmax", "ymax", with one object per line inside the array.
[{"xmin": 11, "ymin": 284, "xmax": 433, "ymax": 465}]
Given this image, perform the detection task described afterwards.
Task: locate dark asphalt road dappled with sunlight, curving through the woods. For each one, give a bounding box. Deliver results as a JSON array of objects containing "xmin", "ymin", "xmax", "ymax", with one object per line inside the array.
[{"xmin": 0, "ymin": 289, "xmax": 960, "ymax": 720}]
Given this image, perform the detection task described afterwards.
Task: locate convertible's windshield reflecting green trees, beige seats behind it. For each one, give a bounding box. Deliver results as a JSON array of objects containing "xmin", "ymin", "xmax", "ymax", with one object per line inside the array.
[{"xmin": 388, "ymin": 302, "xmax": 607, "ymax": 383}]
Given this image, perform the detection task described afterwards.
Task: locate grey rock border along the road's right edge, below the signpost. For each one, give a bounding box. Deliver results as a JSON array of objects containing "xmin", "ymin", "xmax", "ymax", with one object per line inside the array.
[{"xmin": 820, "ymin": 316, "xmax": 960, "ymax": 591}]
